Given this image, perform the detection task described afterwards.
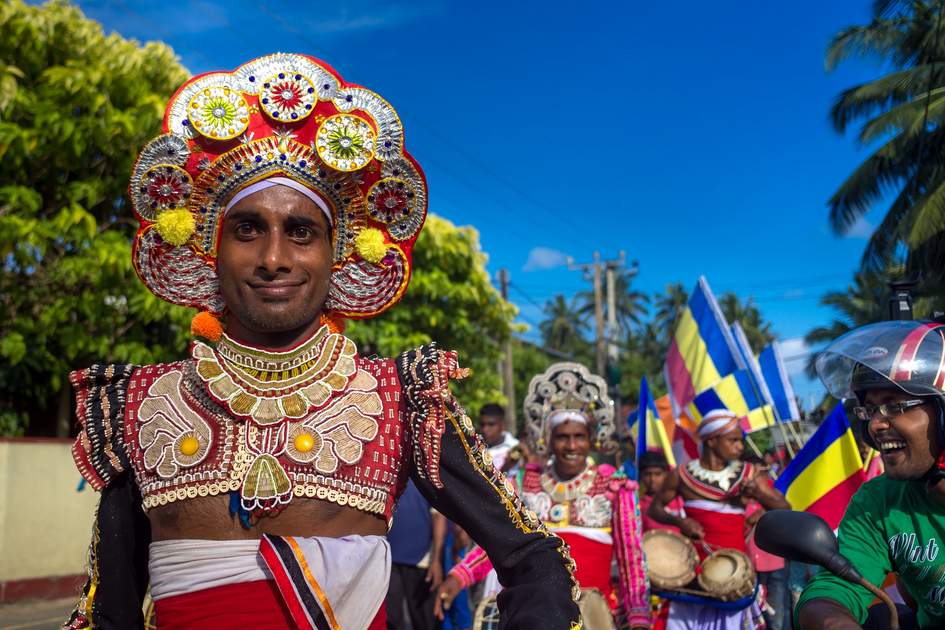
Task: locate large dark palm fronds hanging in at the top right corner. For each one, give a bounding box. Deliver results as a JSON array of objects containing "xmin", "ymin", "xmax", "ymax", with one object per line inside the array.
[{"xmin": 826, "ymin": 0, "xmax": 945, "ymax": 293}]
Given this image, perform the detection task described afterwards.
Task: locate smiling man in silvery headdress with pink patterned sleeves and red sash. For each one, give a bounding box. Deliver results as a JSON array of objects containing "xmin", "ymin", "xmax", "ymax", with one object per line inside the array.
[{"xmin": 440, "ymin": 363, "xmax": 650, "ymax": 630}]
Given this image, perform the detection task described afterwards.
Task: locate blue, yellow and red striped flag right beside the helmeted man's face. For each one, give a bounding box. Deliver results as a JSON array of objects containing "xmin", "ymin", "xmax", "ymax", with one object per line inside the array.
[{"xmin": 774, "ymin": 403, "xmax": 866, "ymax": 529}]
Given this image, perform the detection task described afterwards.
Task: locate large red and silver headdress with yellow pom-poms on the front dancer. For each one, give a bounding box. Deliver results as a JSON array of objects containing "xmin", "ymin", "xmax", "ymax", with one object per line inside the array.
[{"xmin": 129, "ymin": 54, "xmax": 427, "ymax": 318}]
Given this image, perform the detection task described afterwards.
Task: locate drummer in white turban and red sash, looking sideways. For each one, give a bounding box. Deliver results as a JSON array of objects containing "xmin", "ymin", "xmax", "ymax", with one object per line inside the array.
[{"xmin": 649, "ymin": 409, "xmax": 790, "ymax": 630}]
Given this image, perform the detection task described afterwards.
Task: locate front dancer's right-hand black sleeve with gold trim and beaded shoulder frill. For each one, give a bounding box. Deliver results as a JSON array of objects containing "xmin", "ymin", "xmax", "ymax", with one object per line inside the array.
[{"xmin": 398, "ymin": 346, "xmax": 580, "ymax": 630}]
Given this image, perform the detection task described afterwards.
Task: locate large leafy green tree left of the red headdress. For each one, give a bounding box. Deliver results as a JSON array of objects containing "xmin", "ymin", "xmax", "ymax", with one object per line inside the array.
[{"xmin": 0, "ymin": 0, "xmax": 189, "ymax": 434}]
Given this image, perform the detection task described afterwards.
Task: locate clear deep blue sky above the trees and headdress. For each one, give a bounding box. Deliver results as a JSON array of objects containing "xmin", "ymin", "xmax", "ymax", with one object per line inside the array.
[{"xmin": 78, "ymin": 0, "xmax": 883, "ymax": 403}]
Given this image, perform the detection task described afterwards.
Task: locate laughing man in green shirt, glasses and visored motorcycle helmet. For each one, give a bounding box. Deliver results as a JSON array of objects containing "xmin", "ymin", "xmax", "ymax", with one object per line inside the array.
[{"xmin": 795, "ymin": 321, "xmax": 945, "ymax": 630}]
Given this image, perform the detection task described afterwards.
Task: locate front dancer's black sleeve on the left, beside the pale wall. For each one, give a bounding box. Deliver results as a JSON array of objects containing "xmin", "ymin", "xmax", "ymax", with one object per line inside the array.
[{"xmin": 67, "ymin": 473, "xmax": 151, "ymax": 630}]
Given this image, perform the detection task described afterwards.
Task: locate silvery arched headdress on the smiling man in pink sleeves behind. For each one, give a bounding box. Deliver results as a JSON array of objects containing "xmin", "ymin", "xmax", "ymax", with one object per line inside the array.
[{"xmin": 525, "ymin": 363, "xmax": 617, "ymax": 455}]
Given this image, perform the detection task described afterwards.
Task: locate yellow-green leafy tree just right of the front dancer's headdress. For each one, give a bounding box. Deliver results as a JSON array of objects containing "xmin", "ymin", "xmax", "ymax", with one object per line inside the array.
[{"xmin": 346, "ymin": 215, "xmax": 515, "ymax": 412}]
